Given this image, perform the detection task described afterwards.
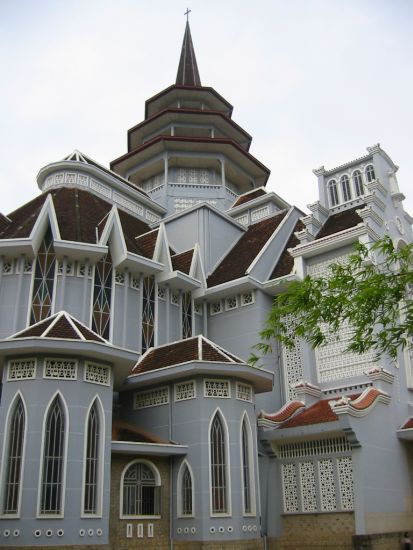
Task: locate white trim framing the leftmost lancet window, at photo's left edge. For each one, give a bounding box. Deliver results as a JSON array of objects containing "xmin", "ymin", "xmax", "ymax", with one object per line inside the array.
[{"xmin": 0, "ymin": 390, "xmax": 29, "ymax": 519}]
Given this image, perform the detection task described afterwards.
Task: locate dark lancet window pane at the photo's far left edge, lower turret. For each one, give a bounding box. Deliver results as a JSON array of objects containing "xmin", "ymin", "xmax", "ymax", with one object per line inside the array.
[{"xmin": 3, "ymin": 396, "xmax": 26, "ymax": 514}]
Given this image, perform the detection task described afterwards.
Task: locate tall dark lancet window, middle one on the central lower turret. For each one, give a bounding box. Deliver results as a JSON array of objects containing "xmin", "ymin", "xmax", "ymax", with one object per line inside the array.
[{"xmin": 210, "ymin": 412, "xmax": 229, "ymax": 514}]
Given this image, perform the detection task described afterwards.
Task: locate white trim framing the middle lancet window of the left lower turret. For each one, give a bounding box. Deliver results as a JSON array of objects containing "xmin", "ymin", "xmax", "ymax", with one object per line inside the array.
[{"xmin": 36, "ymin": 390, "xmax": 69, "ymax": 519}]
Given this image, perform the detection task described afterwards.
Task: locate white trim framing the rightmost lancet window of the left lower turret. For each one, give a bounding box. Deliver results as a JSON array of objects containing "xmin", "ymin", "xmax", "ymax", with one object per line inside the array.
[{"xmin": 80, "ymin": 394, "xmax": 106, "ymax": 518}]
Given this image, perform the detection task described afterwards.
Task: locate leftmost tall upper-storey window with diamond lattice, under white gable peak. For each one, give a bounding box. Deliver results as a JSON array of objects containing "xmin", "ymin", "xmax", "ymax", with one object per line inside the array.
[{"xmin": 30, "ymin": 226, "xmax": 56, "ymax": 325}]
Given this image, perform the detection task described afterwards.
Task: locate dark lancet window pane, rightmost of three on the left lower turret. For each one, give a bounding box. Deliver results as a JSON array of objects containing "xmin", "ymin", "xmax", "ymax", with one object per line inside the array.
[{"xmin": 83, "ymin": 399, "xmax": 102, "ymax": 514}]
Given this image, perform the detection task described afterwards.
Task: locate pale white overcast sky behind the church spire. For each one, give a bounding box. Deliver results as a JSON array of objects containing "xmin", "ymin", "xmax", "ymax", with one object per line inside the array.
[{"xmin": 0, "ymin": 0, "xmax": 413, "ymax": 218}]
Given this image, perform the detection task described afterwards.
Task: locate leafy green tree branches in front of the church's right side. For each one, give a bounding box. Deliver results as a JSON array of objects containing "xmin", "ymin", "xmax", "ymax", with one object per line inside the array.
[{"xmin": 249, "ymin": 237, "xmax": 413, "ymax": 364}]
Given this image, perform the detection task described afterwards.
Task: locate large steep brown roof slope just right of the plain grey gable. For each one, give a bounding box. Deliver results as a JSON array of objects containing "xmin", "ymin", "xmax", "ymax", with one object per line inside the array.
[{"xmin": 208, "ymin": 211, "xmax": 287, "ymax": 287}]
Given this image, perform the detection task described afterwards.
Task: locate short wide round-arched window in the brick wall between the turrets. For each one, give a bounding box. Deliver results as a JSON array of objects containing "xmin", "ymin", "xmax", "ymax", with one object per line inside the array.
[{"xmin": 122, "ymin": 461, "xmax": 161, "ymax": 517}]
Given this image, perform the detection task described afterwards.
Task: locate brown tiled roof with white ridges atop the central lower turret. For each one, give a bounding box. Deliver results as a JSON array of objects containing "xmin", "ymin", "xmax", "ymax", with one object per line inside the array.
[{"xmin": 131, "ymin": 335, "xmax": 243, "ymax": 375}]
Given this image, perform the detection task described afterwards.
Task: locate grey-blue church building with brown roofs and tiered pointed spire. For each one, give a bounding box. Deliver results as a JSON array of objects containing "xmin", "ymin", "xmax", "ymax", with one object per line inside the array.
[{"xmin": 0, "ymin": 24, "xmax": 413, "ymax": 550}]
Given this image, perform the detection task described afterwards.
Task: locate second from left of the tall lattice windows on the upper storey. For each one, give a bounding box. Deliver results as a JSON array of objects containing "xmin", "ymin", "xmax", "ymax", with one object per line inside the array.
[{"xmin": 92, "ymin": 252, "xmax": 113, "ymax": 340}]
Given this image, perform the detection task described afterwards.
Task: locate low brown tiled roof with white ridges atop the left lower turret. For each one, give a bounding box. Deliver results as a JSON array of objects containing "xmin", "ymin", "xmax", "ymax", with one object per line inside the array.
[{"xmin": 10, "ymin": 311, "xmax": 106, "ymax": 343}]
